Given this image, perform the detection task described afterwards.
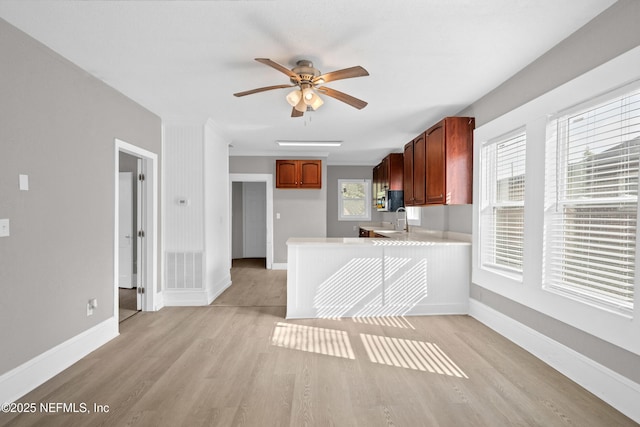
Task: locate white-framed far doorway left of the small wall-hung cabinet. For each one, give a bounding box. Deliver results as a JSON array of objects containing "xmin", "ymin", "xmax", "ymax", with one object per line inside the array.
[{"xmin": 229, "ymin": 174, "xmax": 273, "ymax": 269}]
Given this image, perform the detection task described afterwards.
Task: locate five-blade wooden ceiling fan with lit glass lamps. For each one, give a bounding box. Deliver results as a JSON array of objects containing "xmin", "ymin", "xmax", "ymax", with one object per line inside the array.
[{"xmin": 233, "ymin": 58, "xmax": 369, "ymax": 117}]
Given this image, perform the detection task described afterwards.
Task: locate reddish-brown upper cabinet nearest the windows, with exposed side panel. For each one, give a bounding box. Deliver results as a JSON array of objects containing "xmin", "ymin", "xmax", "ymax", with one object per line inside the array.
[{"xmin": 424, "ymin": 117, "xmax": 475, "ymax": 205}]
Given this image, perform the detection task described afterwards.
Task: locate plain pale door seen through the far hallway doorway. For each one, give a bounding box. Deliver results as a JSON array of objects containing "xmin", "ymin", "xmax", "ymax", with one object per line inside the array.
[{"xmin": 242, "ymin": 182, "xmax": 267, "ymax": 258}]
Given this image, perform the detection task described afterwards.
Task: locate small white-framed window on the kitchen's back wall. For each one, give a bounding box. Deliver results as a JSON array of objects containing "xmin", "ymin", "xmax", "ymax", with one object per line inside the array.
[{"xmin": 338, "ymin": 179, "xmax": 371, "ymax": 221}]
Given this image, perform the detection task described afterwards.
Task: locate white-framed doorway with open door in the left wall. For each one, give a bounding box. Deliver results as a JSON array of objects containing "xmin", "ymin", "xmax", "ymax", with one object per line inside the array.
[{"xmin": 114, "ymin": 139, "xmax": 158, "ymax": 321}]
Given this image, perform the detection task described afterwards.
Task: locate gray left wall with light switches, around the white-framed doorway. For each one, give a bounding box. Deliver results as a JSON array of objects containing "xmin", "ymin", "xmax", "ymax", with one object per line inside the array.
[{"xmin": 0, "ymin": 19, "xmax": 161, "ymax": 374}]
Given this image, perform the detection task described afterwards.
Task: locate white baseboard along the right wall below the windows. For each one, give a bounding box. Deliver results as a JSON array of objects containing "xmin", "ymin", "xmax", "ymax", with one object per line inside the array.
[{"xmin": 469, "ymin": 299, "xmax": 640, "ymax": 423}]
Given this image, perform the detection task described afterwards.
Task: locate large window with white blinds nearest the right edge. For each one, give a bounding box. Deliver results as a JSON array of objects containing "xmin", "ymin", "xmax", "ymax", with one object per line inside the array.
[{"xmin": 544, "ymin": 86, "xmax": 640, "ymax": 311}]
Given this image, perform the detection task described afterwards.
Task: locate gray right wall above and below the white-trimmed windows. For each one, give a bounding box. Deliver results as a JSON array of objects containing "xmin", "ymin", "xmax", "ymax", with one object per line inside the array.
[{"xmin": 456, "ymin": 0, "xmax": 640, "ymax": 382}]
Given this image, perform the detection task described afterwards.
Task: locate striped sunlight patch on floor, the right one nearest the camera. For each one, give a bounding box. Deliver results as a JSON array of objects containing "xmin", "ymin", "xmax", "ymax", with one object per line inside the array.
[{"xmin": 360, "ymin": 334, "xmax": 469, "ymax": 378}]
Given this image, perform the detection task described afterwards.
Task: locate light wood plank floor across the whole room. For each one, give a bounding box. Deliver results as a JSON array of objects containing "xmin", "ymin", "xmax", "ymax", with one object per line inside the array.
[{"xmin": 0, "ymin": 263, "xmax": 637, "ymax": 427}]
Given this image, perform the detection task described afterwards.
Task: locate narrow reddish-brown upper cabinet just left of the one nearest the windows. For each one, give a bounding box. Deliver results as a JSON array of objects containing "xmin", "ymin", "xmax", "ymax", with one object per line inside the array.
[{"xmin": 403, "ymin": 133, "xmax": 426, "ymax": 206}]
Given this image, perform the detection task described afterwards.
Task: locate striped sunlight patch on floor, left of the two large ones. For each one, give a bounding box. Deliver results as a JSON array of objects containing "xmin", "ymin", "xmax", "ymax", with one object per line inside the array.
[{"xmin": 271, "ymin": 322, "xmax": 355, "ymax": 359}]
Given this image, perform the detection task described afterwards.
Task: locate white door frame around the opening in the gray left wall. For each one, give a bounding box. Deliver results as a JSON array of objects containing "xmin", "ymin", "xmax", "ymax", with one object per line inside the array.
[{"xmin": 113, "ymin": 138, "xmax": 160, "ymax": 318}]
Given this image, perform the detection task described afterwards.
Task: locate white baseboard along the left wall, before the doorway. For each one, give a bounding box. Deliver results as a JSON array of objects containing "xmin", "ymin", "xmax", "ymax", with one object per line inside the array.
[{"xmin": 0, "ymin": 317, "xmax": 119, "ymax": 403}]
